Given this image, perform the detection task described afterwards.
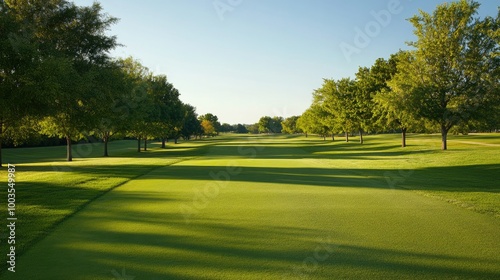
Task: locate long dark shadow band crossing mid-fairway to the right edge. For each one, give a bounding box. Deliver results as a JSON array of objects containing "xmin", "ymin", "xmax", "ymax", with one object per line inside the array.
[{"xmin": 141, "ymin": 164, "xmax": 500, "ymax": 193}]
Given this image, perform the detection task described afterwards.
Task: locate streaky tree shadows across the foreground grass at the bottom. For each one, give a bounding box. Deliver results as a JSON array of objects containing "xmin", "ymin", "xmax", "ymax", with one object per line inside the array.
[{"xmin": 14, "ymin": 198, "xmax": 500, "ymax": 279}]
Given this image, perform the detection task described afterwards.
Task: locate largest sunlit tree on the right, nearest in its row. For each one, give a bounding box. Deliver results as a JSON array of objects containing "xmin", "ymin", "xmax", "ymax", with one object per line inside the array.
[{"xmin": 402, "ymin": 0, "xmax": 500, "ymax": 150}]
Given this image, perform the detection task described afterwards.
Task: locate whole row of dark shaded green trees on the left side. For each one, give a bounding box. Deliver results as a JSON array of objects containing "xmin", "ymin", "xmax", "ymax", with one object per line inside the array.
[{"xmin": 0, "ymin": 0, "xmax": 227, "ymax": 165}]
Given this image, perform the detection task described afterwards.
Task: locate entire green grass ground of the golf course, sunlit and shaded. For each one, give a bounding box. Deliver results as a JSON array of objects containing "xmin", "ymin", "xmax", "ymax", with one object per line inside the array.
[{"xmin": 0, "ymin": 134, "xmax": 500, "ymax": 279}]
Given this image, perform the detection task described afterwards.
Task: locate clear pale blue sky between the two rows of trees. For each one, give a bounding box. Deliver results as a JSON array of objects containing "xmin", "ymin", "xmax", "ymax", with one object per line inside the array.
[{"xmin": 75, "ymin": 0, "xmax": 499, "ymax": 124}]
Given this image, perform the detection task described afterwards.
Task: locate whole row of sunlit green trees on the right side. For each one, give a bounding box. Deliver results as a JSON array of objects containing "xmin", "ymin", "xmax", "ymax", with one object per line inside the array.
[{"xmin": 296, "ymin": 0, "xmax": 500, "ymax": 150}]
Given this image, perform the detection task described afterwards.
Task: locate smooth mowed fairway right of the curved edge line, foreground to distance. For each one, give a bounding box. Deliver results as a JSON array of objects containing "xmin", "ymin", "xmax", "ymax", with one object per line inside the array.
[{"xmin": 7, "ymin": 137, "xmax": 500, "ymax": 279}]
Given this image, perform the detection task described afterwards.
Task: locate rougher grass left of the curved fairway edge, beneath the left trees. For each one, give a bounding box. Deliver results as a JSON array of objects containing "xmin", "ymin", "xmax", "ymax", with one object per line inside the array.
[{"xmin": 0, "ymin": 138, "xmax": 216, "ymax": 271}]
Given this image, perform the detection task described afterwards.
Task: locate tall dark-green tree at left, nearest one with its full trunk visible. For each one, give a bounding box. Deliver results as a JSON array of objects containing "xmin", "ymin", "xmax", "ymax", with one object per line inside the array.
[{"xmin": 11, "ymin": 0, "xmax": 117, "ymax": 161}]
